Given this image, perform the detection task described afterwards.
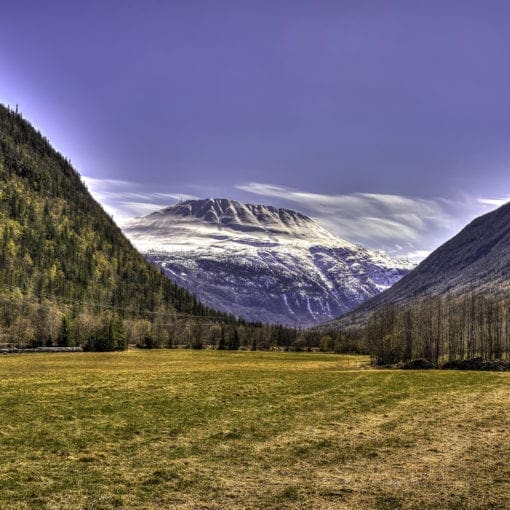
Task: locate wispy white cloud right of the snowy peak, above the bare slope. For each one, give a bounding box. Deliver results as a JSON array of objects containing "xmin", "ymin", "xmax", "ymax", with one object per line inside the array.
[{"xmin": 236, "ymin": 182, "xmax": 494, "ymax": 262}]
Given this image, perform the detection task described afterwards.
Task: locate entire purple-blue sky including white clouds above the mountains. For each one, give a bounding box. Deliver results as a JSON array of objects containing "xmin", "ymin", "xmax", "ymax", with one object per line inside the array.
[{"xmin": 0, "ymin": 0, "xmax": 510, "ymax": 260}]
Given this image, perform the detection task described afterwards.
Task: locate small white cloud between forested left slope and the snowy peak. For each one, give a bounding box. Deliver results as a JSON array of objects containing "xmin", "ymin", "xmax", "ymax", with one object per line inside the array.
[{"xmin": 82, "ymin": 177, "xmax": 197, "ymax": 226}]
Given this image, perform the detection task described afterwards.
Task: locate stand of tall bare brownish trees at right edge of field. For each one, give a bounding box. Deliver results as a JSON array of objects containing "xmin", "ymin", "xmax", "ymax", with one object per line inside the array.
[{"xmin": 362, "ymin": 293, "xmax": 510, "ymax": 365}]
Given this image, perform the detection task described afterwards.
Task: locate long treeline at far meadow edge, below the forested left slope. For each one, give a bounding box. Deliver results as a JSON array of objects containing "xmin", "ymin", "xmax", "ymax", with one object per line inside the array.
[{"xmin": 0, "ymin": 289, "xmax": 365, "ymax": 352}]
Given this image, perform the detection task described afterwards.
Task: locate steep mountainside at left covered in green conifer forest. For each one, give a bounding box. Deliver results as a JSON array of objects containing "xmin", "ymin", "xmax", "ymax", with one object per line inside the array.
[{"xmin": 0, "ymin": 105, "xmax": 225, "ymax": 346}]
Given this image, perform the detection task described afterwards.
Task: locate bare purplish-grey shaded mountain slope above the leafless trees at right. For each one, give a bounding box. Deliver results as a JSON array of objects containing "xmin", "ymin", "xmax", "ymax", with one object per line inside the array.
[{"xmin": 332, "ymin": 203, "xmax": 510, "ymax": 327}]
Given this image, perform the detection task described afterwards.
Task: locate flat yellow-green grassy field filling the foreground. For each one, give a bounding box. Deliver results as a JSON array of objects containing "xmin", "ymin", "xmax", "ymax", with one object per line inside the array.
[{"xmin": 0, "ymin": 350, "xmax": 510, "ymax": 509}]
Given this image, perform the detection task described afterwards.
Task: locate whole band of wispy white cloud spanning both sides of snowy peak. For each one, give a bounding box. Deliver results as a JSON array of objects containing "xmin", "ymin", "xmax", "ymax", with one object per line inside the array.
[{"xmin": 83, "ymin": 177, "xmax": 504, "ymax": 262}]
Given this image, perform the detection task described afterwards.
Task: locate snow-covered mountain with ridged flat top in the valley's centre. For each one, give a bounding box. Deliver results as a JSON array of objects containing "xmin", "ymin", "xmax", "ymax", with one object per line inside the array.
[{"xmin": 124, "ymin": 199, "xmax": 412, "ymax": 326}]
